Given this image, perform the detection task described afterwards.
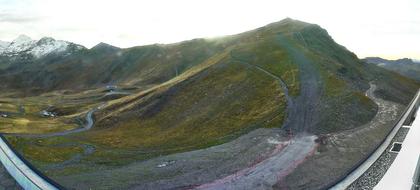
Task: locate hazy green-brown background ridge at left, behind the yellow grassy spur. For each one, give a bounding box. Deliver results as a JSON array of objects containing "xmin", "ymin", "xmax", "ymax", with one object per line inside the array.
[{"xmin": 0, "ymin": 39, "xmax": 223, "ymax": 96}]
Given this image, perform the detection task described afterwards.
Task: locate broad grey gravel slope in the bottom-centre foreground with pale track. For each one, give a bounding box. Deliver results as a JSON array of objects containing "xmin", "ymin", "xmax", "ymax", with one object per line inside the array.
[{"xmin": 50, "ymin": 129, "xmax": 317, "ymax": 189}]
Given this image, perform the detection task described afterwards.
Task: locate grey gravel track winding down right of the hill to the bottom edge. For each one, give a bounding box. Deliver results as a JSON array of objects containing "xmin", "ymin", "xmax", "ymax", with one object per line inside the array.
[{"xmin": 276, "ymin": 84, "xmax": 404, "ymax": 189}]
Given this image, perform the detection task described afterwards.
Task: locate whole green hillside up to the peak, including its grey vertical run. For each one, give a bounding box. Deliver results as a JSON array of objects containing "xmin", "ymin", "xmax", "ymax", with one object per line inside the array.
[{"xmin": 0, "ymin": 19, "xmax": 420, "ymax": 189}]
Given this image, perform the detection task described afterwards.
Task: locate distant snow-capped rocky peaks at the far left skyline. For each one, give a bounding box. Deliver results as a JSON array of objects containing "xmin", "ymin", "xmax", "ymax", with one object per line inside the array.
[{"xmin": 0, "ymin": 35, "xmax": 85, "ymax": 58}]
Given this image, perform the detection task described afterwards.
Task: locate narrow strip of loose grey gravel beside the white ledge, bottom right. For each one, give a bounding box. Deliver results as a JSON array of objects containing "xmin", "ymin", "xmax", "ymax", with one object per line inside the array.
[{"xmin": 347, "ymin": 127, "xmax": 409, "ymax": 190}]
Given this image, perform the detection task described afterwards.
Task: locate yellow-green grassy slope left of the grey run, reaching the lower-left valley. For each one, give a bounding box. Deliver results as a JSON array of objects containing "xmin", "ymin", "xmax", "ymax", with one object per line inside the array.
[{"xmin": 6, "ymin": 49, "xmax": 285, "ymax": 175}]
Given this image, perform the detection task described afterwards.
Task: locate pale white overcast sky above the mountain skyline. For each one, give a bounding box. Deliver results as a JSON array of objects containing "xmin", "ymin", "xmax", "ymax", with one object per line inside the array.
[{"xmin": 0, "ymin": 0, "xmax": 420, "ymax": 59}]
